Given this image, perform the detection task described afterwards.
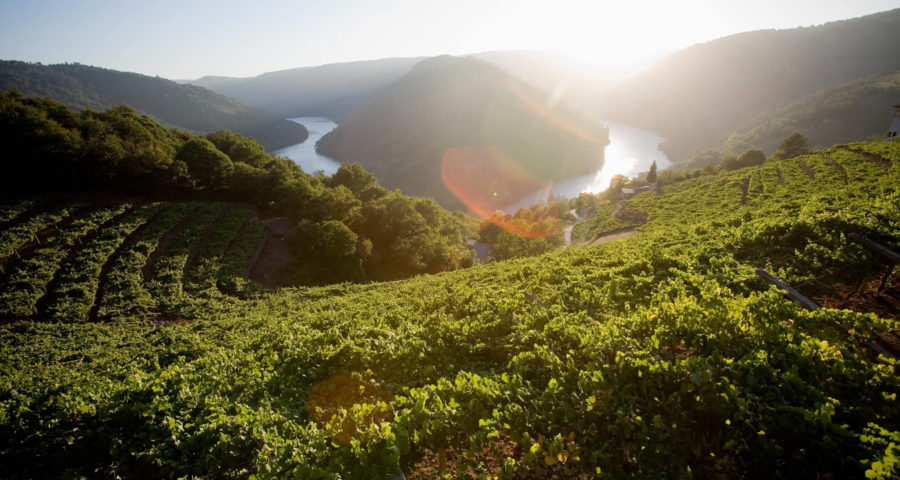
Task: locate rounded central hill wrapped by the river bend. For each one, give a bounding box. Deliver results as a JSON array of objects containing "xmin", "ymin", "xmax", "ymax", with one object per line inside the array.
[{"xmin": 317, "ymin": 56, "xmax": 609, "ymax": 209}]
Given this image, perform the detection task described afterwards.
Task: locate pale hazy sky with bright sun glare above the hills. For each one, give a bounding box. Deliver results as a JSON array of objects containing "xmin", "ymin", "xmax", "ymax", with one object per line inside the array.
[{"xmin": 0, "ymin": 0, "xmax": 900, "ymax": 79}]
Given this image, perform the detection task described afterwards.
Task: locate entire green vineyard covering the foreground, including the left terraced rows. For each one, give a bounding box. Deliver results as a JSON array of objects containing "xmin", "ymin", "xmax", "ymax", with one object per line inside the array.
[{"xmin": 0, "ymin": 142, "xmax": 900, "ymax": 479}]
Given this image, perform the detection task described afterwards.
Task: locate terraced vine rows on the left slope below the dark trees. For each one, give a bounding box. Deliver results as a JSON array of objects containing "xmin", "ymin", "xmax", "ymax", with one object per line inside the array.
[{"xmin": 0, "ymin": 200, "xmax": 263, "ymax": 325}]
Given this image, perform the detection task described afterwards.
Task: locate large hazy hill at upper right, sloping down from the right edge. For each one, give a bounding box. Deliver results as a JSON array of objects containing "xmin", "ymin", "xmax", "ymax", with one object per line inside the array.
[{"xmin": 598, "ymin": 9, "xmax": 900, "ymax": 162}]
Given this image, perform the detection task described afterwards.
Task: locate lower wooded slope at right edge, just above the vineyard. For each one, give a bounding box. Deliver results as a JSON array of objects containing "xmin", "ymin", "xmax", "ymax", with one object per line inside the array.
[{"xmin": 722, "ymin": 71, "xmax": 900, "ymax": 154}]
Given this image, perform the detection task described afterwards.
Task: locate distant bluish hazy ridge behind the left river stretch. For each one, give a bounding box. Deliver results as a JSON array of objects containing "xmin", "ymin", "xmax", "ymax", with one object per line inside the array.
[{"xmin": 189, "ymin": 57, "xmax": 424, "ymax": 123}]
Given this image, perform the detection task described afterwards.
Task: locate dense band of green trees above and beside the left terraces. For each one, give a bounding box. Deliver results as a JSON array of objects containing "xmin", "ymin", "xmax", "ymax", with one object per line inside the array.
[{"xmin": 0, "ymin": 93, "xmax": 473, "ymax": 283}]
